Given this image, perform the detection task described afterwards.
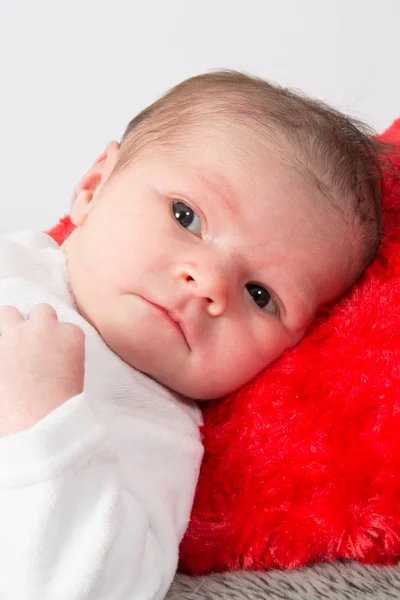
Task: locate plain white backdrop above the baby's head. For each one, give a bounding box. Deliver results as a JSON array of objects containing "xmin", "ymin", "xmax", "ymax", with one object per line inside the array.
[{"xmin": 0, "ymin": 0, "xmax": 400, "ymax": 230}]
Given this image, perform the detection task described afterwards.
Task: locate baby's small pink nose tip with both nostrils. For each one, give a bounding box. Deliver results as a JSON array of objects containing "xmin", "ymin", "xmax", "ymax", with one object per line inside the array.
[{"xmin": 176, "ymin": 263, "xmax": 229, "ymax": 317}]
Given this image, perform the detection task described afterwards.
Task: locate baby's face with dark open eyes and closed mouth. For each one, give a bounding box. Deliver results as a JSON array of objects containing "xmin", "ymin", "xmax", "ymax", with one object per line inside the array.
[{"xmin": 63, "ymin": 134, "xmax": 354, "ymax": 399}]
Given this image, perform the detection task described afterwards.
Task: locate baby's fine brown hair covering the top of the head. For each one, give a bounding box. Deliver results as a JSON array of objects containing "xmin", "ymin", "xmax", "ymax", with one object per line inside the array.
[{"xmin": 115, "ymin": 71, "xmax": 385, "ymax": 274}]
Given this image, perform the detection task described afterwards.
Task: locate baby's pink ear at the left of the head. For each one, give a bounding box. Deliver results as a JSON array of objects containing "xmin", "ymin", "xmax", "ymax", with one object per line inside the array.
[{"xmin": 70, "ymin": 142, "xmax": 120, "ymax": 226}]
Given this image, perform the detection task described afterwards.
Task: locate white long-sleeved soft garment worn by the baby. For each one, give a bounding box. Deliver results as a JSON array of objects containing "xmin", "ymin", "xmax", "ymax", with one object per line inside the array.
[{"xmin": 0, "ymin": 232, "xmax": 202, "ymax": 600}]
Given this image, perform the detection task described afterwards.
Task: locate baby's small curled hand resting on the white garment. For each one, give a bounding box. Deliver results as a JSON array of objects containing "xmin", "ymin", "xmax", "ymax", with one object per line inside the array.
[{"xmin": 0, "ymin": 304, "xmax": 85, "ymax": 435}]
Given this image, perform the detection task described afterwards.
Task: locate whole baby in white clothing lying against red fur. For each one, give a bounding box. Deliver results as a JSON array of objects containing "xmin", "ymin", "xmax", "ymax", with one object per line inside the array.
[{"xmin": 0, "ymin": 72, "xmax": 381, "ymax": 600}]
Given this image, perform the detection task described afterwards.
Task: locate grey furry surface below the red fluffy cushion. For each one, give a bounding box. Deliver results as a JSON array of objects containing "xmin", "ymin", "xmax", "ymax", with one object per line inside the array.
[{"xmin": 167, "ymin": 563, "xmax": 400, "ymax": 600}]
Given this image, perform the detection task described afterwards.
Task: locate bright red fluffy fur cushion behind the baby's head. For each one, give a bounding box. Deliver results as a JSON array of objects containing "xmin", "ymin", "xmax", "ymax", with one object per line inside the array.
[{"xmin": 50, "ymin": 119, "xmax": 400, "ymax": 574}]
